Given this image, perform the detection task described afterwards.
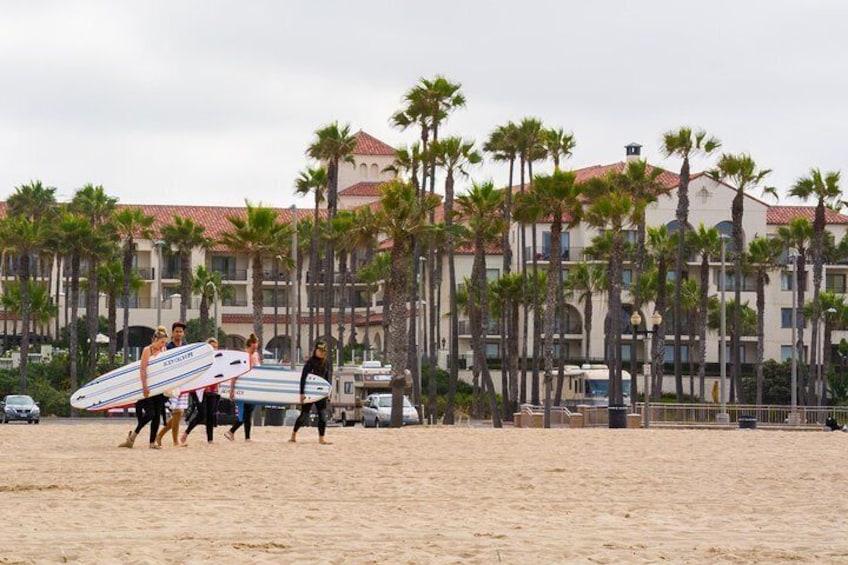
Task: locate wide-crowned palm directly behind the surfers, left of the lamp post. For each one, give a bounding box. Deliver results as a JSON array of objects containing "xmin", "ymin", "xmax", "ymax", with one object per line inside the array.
[{"xmin": 220, "ymin": 201, "xmax": 291, "ymax": 347}]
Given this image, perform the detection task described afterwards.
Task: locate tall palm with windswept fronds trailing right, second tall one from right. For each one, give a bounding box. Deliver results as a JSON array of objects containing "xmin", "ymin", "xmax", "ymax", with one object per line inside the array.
[{"xmin": 711, "ymin": 153, "xmax": 774, "ymax": 404}]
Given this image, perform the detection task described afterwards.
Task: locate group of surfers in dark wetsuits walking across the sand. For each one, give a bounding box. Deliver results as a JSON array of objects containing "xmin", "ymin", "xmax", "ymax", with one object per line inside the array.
[{"xmin": 118, "ymin": 322, "xmax": 330, "ymax": 449}]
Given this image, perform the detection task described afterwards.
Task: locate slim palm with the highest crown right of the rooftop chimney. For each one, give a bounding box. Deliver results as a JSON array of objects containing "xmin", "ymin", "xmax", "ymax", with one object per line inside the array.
[{"xmin": 662, "ymin": 126, "xmax": 721, "ymax": 392}]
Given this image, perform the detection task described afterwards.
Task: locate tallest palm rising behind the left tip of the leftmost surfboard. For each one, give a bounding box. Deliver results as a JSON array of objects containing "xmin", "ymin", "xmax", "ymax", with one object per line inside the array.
[{"xmin": 70, "ymin": 184, "xmax": 118, "ymax": 376}]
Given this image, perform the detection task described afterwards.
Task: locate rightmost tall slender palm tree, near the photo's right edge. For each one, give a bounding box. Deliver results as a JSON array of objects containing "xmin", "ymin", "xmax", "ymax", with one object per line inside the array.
[{"xmin": 789, "ymin": 169, "xmax": 842, "ymax": 406}]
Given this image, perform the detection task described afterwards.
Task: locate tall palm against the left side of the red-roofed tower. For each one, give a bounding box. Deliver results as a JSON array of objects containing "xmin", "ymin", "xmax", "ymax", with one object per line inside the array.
[{"xmin": 306, "ymin": 122, "xmax": 356, "ymax": 337}]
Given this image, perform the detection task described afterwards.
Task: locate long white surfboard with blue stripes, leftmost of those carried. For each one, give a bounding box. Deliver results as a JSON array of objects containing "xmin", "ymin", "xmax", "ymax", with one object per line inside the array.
[{"xmin": 71, "ymin": 343, "xmax": 215, "ymax": 411}]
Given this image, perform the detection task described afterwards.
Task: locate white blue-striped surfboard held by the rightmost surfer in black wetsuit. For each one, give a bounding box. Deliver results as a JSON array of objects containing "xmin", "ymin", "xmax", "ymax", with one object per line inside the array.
[{"xmin": 218, "ymin": 365, "xmax": 330, "ymax": 404}]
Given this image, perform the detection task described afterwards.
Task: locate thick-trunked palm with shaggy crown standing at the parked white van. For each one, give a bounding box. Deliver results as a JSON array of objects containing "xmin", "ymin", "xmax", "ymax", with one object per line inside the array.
[{"xmin": 376, "ymin": 179, "xmax": 444, "ymax": 427}]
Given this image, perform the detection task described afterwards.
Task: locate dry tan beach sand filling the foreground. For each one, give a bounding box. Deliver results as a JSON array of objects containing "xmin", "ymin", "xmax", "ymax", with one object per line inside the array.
[{"xmin": 0, "ymin": 421, "xmax": 848, "ymax": 564}]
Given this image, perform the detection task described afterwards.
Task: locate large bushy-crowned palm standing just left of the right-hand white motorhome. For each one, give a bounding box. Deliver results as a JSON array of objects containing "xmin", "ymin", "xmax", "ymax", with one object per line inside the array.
[{"xmin": 515, "ymin": 170, "xmax": 584, "ymax": 427}]
